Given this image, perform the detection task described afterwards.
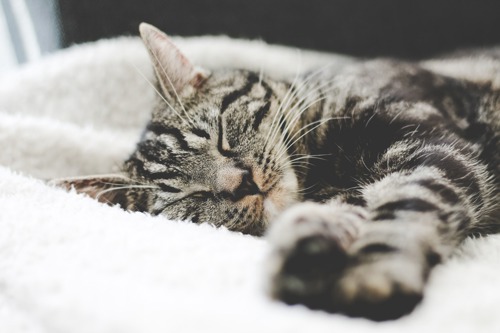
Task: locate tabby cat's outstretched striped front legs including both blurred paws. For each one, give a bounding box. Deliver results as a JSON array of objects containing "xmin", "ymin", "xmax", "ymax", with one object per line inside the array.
[{"xmin": 269, "ymin": 139, "xmax": 491, "ymax": 320}]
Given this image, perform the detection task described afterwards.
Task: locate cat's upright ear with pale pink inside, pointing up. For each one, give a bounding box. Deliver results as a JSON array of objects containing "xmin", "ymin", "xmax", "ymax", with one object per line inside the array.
[{"xmin": 139, "ymin": 23, "xmax": 206, "ymax": 97}]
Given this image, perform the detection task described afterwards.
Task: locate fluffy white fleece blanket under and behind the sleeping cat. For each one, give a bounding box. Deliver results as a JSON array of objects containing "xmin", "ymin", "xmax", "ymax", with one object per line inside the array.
[{"xmin": 0, "ymin": 37, "xmax": 500, "ymax": 333}]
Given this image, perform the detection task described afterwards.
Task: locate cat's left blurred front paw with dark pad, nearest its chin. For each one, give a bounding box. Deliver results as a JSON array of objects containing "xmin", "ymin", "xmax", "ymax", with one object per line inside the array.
[{"xmin": 268, "ymin": 203, "xmax": 365, "ymax": 310}]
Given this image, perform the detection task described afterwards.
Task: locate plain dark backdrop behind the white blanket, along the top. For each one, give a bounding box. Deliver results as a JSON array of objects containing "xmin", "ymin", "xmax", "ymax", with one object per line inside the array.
[{"xmin": 59, "ymin": 0, "xmax": 500, "ymax": 58}]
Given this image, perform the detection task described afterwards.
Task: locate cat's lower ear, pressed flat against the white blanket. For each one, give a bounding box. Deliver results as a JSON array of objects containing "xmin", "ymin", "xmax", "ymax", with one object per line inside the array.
[{"xmin": 48, "ymin": 175, "xmax": 130, "ymax": 209}]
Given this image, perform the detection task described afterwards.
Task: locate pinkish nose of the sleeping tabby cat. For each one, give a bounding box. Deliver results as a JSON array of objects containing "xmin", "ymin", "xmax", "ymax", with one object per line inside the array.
[{"xmin": 217, "ymin": 167, "xmax": 260, "ymax": 200}]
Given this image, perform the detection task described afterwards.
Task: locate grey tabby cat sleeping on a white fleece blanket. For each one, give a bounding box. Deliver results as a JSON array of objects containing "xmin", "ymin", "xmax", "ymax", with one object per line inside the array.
[{"xmin": 60, "ymin": 23, "xmax": 500, "ymax": 320}]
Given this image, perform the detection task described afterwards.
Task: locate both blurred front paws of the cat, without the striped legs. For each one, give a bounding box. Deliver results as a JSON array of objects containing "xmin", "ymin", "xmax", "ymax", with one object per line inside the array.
[{"xmin": 269, "ymin": 204, "xmax": 435, "ymax": 320}]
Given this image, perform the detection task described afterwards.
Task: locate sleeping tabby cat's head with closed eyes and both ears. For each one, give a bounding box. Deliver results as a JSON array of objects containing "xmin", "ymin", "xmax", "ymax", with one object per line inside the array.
[{"xmin": 60, "ymin": 23, "xmax": 298, "ymax": 234}]
